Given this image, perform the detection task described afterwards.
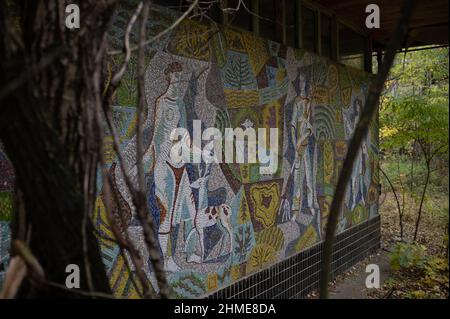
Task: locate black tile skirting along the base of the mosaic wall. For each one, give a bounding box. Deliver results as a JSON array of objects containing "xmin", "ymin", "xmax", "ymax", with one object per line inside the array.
[{"xmin": 207, "ymin": 216, "xmax": 380, "ymax": 299}]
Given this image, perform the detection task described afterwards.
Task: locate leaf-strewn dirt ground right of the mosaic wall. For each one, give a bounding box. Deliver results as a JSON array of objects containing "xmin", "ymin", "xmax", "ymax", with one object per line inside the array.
[{"xmin": 307, "ymin": 192, "xmax": 448, "ymax": 299}]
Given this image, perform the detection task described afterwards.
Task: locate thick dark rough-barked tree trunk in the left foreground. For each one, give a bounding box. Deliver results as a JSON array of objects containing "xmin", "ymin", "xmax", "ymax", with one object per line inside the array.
[{"xmin": 0, "ymin": 0, "xmax": 114, "ymax": 298}]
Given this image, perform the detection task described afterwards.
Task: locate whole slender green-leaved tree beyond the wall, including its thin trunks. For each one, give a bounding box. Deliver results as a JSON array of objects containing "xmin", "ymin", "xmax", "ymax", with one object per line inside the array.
[{"xmin": 380, "ymin": 48, "xmax": 448, "ymax": 241}]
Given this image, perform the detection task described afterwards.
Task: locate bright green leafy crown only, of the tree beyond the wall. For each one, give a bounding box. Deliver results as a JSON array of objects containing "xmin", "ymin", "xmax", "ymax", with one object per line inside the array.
[{"xmin": 380, "ymin": 48, "xmax": 449, "ymax": 153}]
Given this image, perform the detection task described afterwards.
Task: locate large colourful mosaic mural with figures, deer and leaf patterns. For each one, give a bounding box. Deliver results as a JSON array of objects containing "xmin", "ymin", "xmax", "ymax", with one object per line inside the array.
[{"xmin": 0, "ymin": 3, "xmax": 378, "ymax": 298}]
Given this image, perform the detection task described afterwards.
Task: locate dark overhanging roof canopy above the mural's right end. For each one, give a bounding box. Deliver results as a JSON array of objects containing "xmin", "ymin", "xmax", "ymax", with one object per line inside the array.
[{"xmin": 316, "ymin": 0, "xmax": 449, "ymax": 50}]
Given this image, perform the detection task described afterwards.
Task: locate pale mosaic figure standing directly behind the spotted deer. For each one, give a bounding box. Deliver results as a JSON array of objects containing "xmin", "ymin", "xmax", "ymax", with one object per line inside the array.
[{"xmin": 151, "ymin": 62, "xmax": 195, "ymax": 271}]
